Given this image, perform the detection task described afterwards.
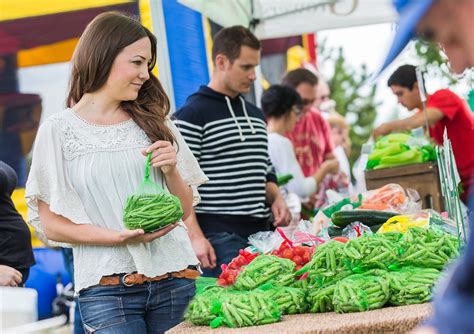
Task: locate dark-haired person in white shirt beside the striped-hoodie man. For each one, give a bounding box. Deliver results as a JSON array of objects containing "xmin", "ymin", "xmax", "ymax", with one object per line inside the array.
[{"xmin": 261, "ymin": 85, "xmax": 339, "ymax": 199}]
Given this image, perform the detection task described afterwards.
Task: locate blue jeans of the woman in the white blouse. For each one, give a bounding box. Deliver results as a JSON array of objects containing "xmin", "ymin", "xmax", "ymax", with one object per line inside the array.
[{"xmin": 79, "ymin": 278, "xmax": 195, "ymax": 334}]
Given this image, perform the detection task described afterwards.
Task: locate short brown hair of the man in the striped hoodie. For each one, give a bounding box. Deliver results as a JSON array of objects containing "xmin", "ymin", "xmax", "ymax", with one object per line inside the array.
[{"xmin": 212, "ymin": 26, "xmax": 261, "ymax": 63}]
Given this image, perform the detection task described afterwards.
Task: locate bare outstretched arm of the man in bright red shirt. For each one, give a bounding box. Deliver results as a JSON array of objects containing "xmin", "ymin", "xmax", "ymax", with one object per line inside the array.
[{"xmin": 374, "ymin": 108, "xmax": 444, "ymax": 138}]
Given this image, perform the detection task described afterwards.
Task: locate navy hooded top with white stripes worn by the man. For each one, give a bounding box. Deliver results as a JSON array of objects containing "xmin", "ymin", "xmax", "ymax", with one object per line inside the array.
[{"xmin": 175, "ymin": 86, "xmax": 276, "ymax": 235}]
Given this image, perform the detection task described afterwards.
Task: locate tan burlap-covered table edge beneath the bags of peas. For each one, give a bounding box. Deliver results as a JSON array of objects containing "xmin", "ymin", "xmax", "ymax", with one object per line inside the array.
[{"xmin": 166, "ymin": 303, "xmax": 432, "ymax": 334}]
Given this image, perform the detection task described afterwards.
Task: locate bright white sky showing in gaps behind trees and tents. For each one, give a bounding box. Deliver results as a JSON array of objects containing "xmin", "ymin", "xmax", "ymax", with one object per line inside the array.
[{"xmin": 19, "ymin": 23, "xmax": 469, "ymax": 125}]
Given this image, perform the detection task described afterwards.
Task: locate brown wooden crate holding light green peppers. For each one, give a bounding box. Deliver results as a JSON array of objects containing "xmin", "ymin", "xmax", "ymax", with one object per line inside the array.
[{"xmin": 365, "ymin": 162, "xmax": 444, "ymax": 212}]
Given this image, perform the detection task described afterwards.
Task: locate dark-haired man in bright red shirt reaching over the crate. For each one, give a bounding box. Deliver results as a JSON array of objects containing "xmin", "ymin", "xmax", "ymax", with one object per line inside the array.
[{"xmin": 374, "ymin": 65, "xmax": 474, "ymax": 201}]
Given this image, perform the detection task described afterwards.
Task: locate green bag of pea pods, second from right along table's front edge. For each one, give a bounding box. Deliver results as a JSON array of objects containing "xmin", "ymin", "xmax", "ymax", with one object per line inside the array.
[{"xmin": 333, "ymin": 275, "xmax": 390, "ymax": 313}]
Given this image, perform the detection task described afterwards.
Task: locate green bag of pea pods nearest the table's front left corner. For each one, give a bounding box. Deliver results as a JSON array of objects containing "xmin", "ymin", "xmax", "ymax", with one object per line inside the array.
[{"xmin": 210, "ymin": 291, "xmax": 281, "ymax": 328}]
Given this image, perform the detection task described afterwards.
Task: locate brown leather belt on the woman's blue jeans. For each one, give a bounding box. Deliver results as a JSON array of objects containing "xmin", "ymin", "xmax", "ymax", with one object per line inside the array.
[{"xmin": 99, "ymin": 269, "xmax": 200, "ymax": 286}]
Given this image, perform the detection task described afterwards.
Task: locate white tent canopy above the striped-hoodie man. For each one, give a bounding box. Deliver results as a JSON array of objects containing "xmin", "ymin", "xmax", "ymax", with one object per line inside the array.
[{"xmin": 178, "ymin": 0, "xmax": 397, "ymax": 39}]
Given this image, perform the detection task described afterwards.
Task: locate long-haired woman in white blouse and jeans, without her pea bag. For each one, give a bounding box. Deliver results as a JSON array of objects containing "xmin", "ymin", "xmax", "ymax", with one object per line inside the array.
[{"xmin": 26, "ymin": 13, "xmax": 207, "ymax": 333}]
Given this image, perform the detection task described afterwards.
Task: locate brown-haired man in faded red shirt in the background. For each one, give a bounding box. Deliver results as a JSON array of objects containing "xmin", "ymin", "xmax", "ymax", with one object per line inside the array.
[{"xmin": 282, "ymin": 68, "xmax": 336, "ymax": 177}]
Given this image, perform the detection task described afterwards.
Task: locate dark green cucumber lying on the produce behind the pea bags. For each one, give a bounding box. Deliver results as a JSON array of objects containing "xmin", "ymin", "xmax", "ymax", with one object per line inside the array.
[{"xmin": 331, "ymin": 210, "xmax": 399, "ymax": 228}]
